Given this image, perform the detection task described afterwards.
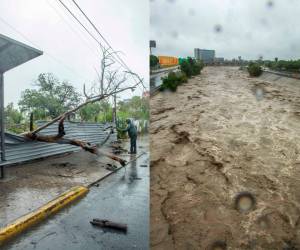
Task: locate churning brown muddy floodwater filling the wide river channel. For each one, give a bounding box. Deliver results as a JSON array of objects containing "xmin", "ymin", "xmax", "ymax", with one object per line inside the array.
[{"xmin": 150, "ymin": 67, "xmax": 300, "ymax": 250}]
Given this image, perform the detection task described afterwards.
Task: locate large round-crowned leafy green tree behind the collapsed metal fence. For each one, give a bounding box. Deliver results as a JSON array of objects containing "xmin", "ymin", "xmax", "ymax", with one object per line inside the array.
[{"xmin": 19, "ymin": 73, "xmax": 80, "ymax": 119}]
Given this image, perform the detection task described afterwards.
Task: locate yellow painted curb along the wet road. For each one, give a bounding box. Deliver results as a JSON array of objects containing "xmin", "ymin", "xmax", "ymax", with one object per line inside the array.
[{"xmin": 0, "ymin": 186, "xmax": 89, "ymax": 245}]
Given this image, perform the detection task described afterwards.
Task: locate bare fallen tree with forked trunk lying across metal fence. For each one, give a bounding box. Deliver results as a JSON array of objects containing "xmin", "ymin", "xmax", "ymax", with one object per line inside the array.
[{"xmin": 22, "ymin": 48, "xmax": 143, "ymax": 166}]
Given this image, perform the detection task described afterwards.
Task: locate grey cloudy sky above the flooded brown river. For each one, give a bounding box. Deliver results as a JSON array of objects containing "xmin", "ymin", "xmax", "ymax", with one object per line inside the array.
[{"xmin": 150, "ymin": 0, "xmax": 300, "ymax": 59}]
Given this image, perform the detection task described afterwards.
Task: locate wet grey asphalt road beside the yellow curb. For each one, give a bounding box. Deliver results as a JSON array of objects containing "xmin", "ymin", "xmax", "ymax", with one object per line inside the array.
[{"xmin": 1, "ymin": 148, "xmax": 149, "ymax": 250}]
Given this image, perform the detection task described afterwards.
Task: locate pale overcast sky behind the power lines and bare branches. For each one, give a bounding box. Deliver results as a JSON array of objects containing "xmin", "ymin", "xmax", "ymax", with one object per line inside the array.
[{"xmin": 0, "ymin": 0, "xmax": 149, "ymax": 104}]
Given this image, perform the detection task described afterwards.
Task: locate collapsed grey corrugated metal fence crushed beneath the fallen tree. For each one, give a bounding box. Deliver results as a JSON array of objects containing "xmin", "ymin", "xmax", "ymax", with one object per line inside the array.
[{"xmin": 0, "ymin": 122, "xmax": 116, "ymax": 165}]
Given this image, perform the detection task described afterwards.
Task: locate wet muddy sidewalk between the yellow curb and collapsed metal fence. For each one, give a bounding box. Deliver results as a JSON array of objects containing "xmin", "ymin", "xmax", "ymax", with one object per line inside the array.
[{"xmin": 0, "ymin": 142, "xmax": 129, "ymax": 227}]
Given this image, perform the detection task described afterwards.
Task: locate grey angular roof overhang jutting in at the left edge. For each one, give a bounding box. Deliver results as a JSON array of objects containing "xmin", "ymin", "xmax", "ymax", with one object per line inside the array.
[{"xmin": 0, "ymin": 34, "xmax": 43, "ymax": 73}]
